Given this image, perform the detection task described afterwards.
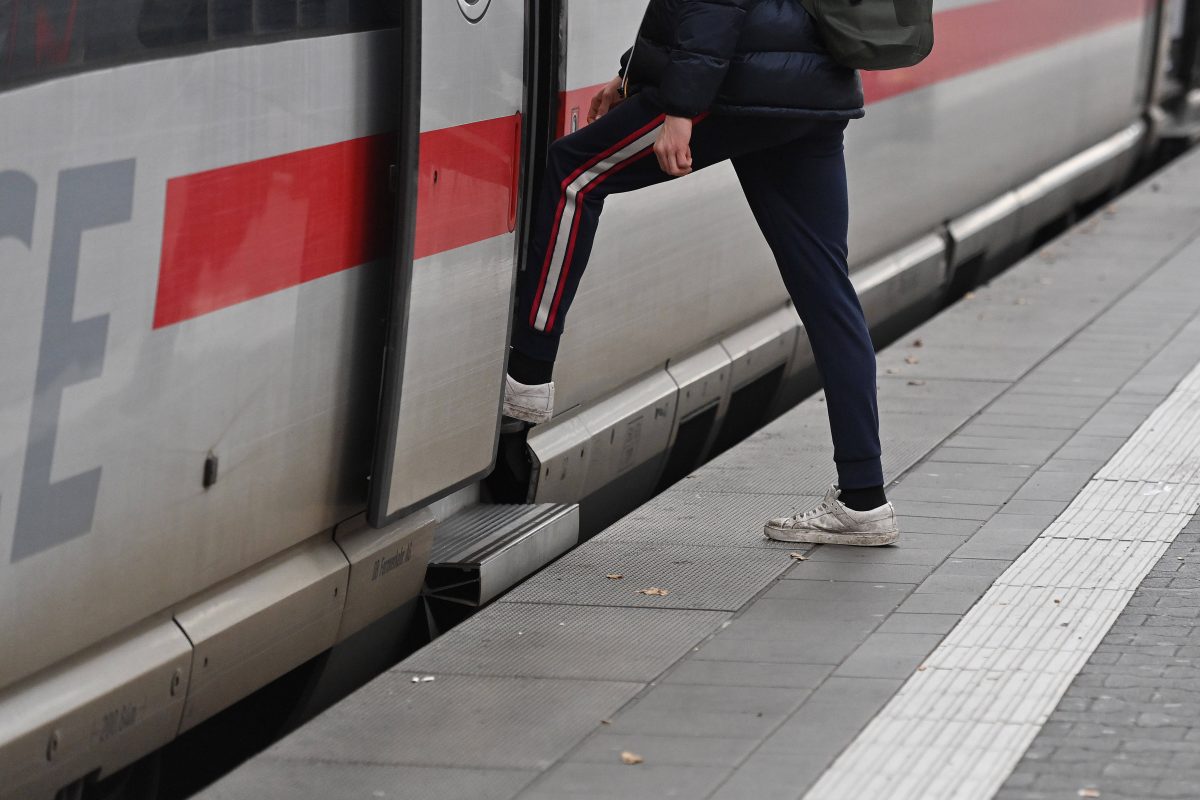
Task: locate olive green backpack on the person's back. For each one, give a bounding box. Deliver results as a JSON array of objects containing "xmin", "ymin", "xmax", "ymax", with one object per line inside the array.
[{"xmin": 800, "ymin": 0, "xmax": 934, "ymax": 70}]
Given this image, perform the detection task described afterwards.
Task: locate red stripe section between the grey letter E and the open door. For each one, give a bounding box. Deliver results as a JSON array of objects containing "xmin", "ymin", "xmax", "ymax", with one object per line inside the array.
[{"xmin": 154, "ymin": 136, "xmax": 395, "ymax": 327}]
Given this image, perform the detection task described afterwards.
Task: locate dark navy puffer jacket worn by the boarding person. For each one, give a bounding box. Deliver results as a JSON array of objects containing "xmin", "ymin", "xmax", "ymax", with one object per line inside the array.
[{"xmin": 622, "ymin": 0, "xmax": 863, "ymax": 119}]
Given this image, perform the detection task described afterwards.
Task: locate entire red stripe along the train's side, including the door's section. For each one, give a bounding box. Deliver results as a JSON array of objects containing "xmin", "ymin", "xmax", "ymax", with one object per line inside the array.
[{"xmin": 154, "ymin": 0, "xmax": 1158, "ymax": 327}]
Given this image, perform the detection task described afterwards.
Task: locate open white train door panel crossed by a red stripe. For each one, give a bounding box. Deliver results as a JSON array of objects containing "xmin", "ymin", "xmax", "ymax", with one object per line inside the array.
[{"xmin": 368, "ymin": 0, "xmax": 527, "ymax": 527}]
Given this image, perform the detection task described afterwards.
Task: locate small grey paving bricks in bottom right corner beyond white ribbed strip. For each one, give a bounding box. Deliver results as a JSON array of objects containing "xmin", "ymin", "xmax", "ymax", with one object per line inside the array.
[{"xmin": 996, "ymin": 515, "xmax": 1200, "ymax": 800}]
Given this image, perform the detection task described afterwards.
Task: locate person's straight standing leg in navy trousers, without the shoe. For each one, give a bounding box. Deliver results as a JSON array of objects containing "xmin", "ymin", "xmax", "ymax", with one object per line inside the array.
[{"xmin": 733, "ymin": 122, "xmax": 883, "ymax": 496}]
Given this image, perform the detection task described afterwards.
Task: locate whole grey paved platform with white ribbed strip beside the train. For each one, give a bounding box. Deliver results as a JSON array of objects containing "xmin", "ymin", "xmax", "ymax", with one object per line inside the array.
[{"xmin": 200, "ymin": 145, "xmax": 1200, "ymax": 800}]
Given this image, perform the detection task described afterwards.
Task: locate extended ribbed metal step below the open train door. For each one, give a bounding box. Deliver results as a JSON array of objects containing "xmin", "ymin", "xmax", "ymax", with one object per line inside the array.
[{"xmin": 424, "ymin": 504, "xmax": 580, "ymax": 608}]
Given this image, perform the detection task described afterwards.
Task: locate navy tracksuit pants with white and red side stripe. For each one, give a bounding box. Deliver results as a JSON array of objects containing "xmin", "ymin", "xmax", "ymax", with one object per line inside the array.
[{"xmin": 512, "ymin": 88, "xmax": 883, "ymax": 489}]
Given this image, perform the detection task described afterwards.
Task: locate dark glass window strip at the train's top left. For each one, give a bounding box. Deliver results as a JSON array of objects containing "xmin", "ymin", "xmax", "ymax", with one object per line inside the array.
[{"xmin": 0, "ymin": 0, "xmax": 402, "ymax": 90}]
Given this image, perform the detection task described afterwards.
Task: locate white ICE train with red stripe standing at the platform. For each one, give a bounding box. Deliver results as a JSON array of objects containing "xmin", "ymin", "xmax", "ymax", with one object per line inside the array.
[{"xmin": 0, "ymin": 0, "xmax": 1200, "ymax": 800}]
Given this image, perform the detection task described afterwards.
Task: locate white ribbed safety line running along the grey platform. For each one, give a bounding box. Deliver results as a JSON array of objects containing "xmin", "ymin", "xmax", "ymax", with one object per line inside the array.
[{"xmin": 805, "ymin": 367, "xmax": 1200, "ymax": 800}]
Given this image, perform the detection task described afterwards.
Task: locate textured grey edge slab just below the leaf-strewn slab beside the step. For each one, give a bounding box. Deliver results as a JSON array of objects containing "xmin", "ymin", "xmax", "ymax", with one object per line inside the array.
[{"xmin": 403, "ymin": 606, "xmax": 730, "ymax": 682}]
